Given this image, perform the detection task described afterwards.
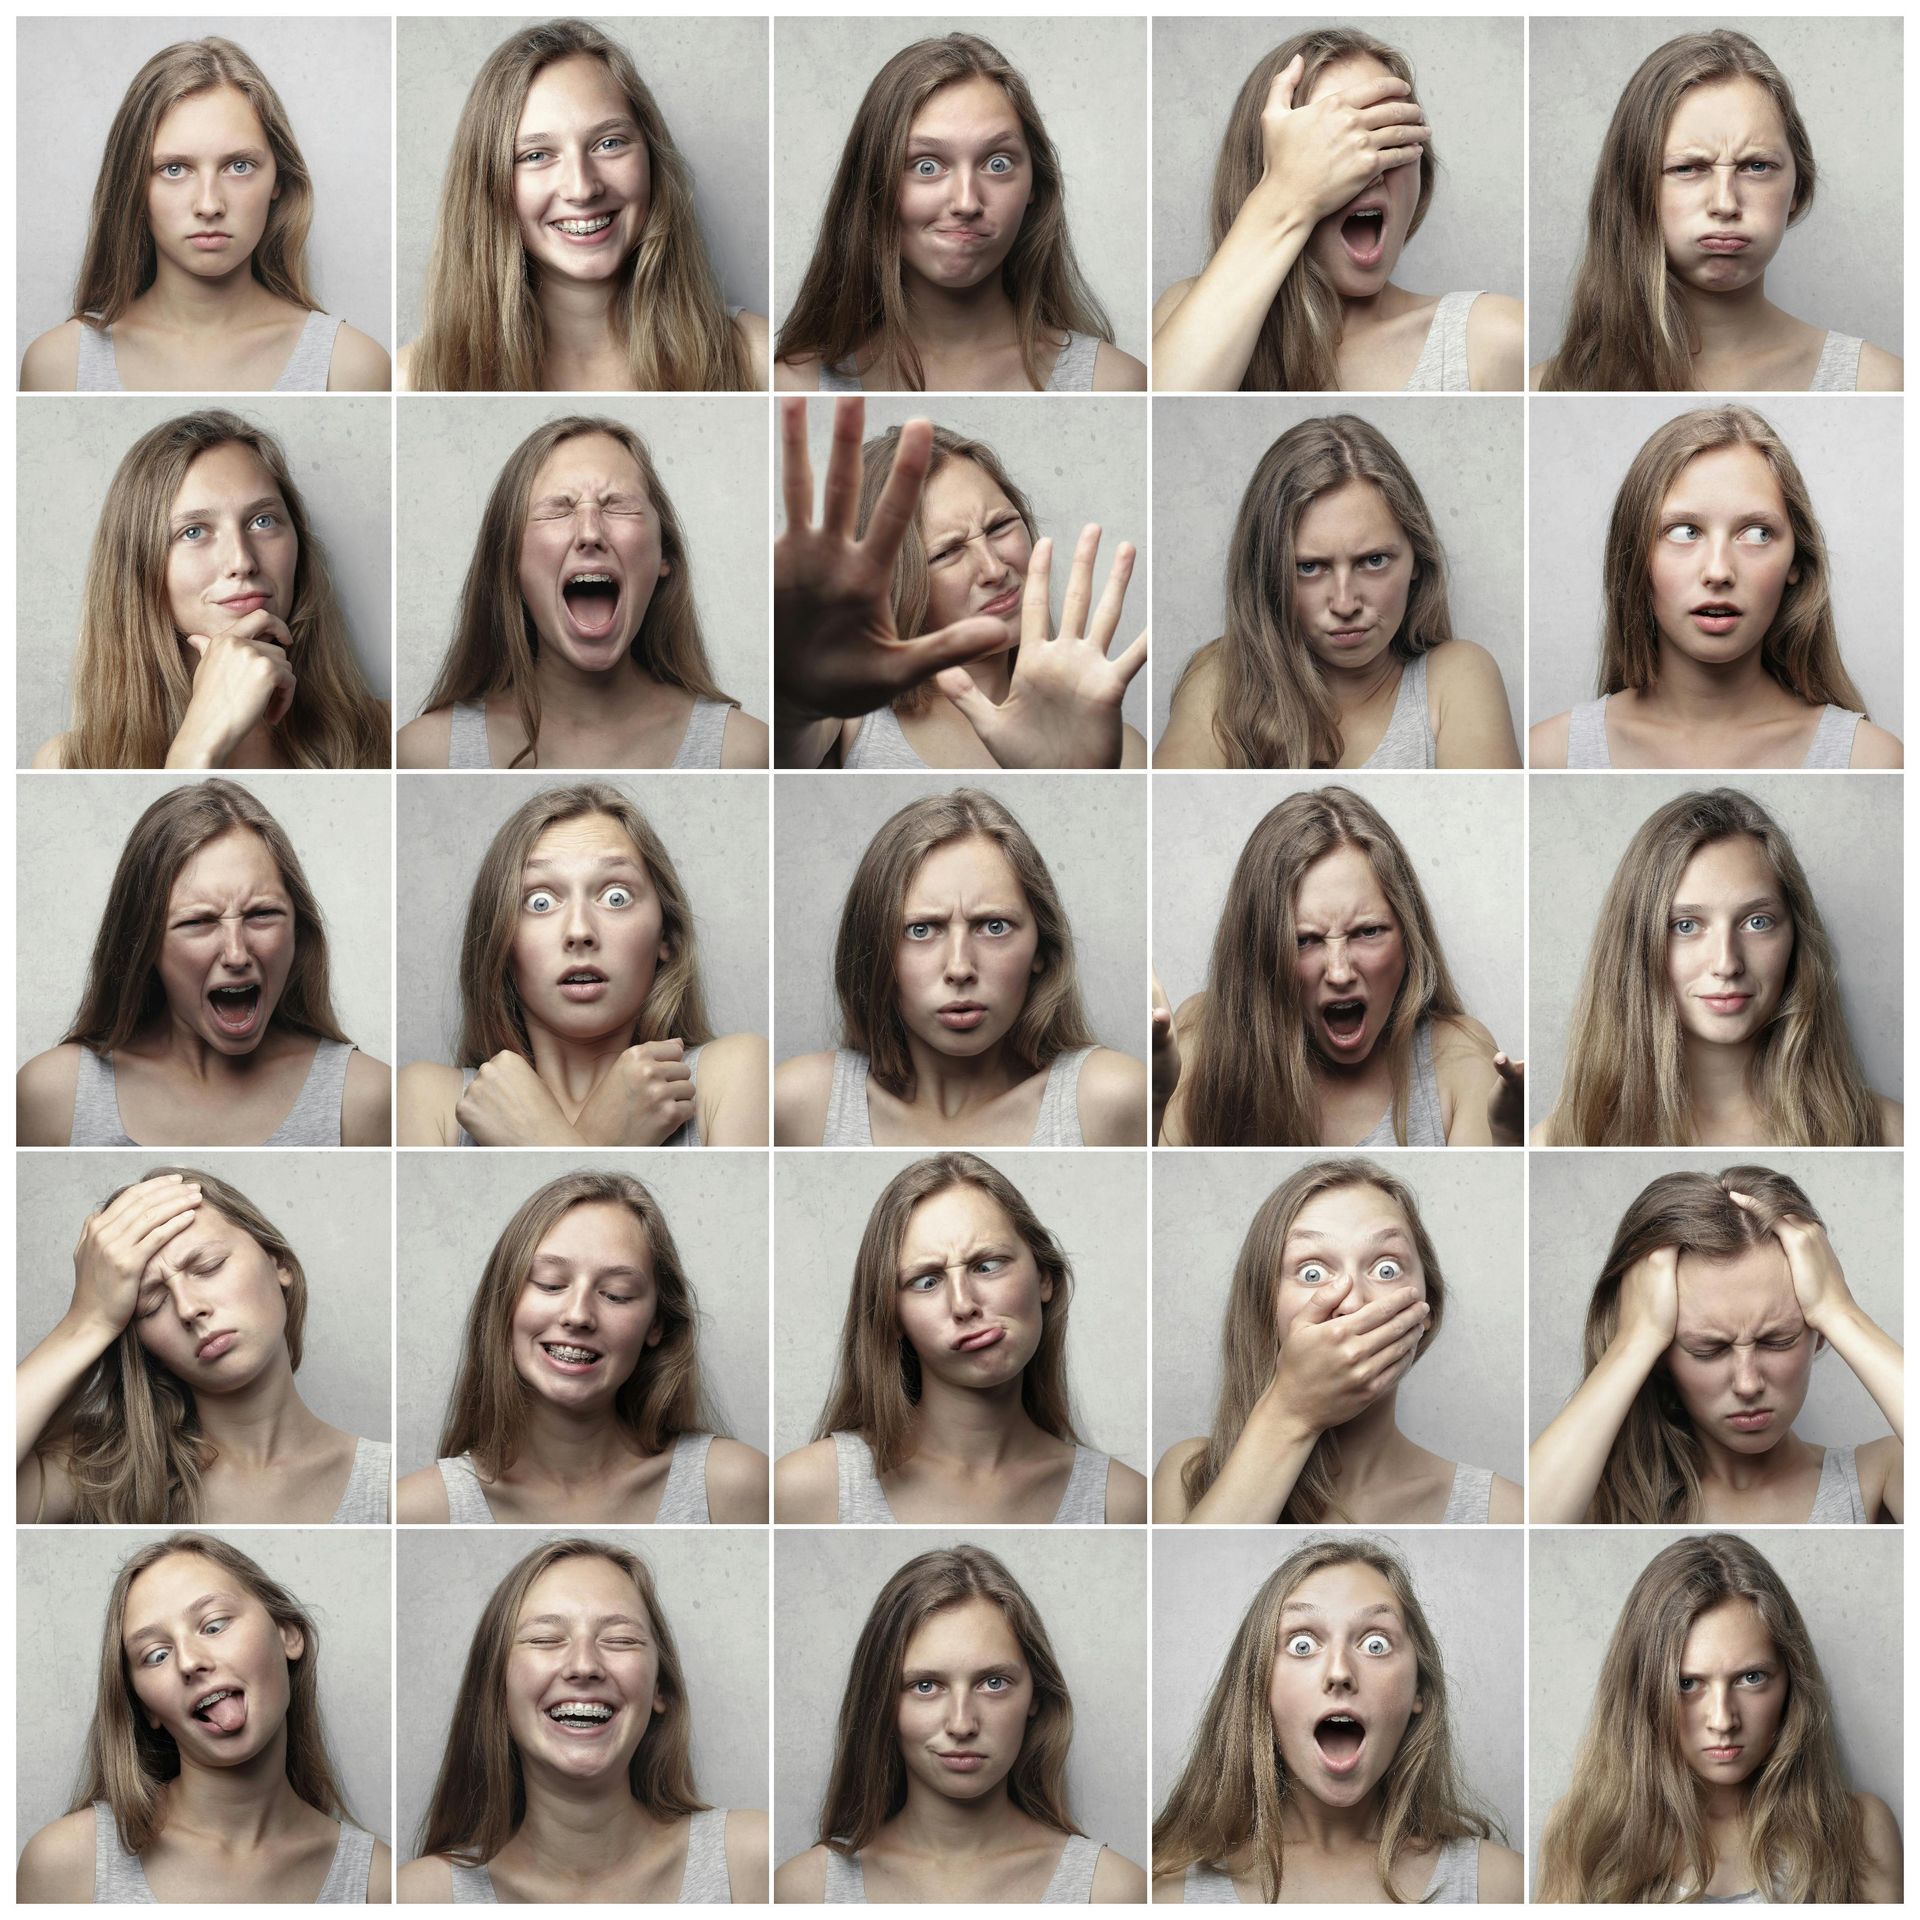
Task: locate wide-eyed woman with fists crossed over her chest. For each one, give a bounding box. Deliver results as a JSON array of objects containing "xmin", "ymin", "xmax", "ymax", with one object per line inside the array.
[{"xmin": 399, "ymin": 780, "xmax": 766, "ymax": 1146}]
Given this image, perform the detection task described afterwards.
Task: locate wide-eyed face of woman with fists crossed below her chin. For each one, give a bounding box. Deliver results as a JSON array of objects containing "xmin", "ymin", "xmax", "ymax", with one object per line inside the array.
[{"xmin": 507, "ymin": 814, "xmax": 670, "ymax": 1043}]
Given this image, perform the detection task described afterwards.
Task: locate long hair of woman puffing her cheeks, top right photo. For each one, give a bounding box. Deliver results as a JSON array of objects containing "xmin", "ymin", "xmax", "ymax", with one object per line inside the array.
[{"xmin": 1540, "ymin": 27, "xmax": 1816, "ymax": 394}]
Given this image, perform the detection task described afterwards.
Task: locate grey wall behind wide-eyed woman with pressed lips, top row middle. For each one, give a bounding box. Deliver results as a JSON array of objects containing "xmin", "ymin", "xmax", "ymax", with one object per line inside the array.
[{"xmin": 774, "ymin": 13, "xmax": 1150, "ymax": 361}]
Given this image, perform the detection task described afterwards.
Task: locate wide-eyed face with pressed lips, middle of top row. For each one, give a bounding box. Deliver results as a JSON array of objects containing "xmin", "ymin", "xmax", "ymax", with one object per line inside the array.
[{"xmin": 895, "ymin": 73, "xmax": 1033, "ymax": 292}]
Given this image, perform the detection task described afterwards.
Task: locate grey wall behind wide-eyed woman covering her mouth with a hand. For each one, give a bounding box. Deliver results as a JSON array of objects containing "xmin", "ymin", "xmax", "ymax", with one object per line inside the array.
[{"xmin": 1154, "ymin": 1148, "xmax": 1524, "ymax": 1484}]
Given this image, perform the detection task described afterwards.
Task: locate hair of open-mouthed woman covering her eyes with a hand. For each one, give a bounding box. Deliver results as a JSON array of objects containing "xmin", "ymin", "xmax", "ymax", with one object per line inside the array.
[{"xmin": 1212, "ymin": 27, "xmax": 1440, "ymax": 394}]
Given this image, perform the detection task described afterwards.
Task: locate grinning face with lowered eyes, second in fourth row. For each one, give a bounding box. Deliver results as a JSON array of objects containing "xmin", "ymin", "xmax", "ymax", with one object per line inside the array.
[{"xmin": 513, "ymin": 1200, "xmax": 660, "ymax": 1413}]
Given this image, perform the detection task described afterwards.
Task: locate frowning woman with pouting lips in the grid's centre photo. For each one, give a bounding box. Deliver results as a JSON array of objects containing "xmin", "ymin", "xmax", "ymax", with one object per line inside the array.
[{"xmin": 774, "ymin": 787, "xmax": 1146, "ymax": 1146}]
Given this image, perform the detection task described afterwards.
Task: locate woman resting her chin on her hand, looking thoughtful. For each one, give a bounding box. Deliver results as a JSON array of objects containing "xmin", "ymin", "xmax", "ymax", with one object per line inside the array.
[{"xmin": 33, "ymin": 407, "xmax": 394, "ymax": 768}]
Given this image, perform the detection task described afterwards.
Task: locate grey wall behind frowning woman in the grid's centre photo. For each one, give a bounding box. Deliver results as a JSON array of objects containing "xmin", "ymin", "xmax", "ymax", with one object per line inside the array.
[{"xmin": 774, "ymin": 770, "xmax": 1146, "ymax": 1060}]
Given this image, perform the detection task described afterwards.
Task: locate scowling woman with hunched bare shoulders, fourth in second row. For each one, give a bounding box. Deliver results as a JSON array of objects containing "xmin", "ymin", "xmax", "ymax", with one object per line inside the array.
[{"xmin": 1154, "ymin": 413, "xmax": 1521, "ymax": 766}]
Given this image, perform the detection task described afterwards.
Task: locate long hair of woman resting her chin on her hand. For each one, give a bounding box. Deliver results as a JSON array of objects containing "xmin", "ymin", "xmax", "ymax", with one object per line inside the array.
[{"xmin": 61, "ymin": 407, "xmax": 394, "ymax": 768}]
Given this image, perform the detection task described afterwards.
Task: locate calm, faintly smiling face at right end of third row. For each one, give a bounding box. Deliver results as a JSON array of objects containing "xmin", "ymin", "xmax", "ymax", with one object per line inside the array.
[{"xmin": 1667, "ymin": 833, "xmax": 1793, "ymax": 1046}]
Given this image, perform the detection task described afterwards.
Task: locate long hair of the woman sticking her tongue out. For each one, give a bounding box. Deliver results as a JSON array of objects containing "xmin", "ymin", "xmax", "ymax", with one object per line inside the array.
[{"xmin": 67, "ymin": 1532, "xmax": 353, "ymax": 1853}]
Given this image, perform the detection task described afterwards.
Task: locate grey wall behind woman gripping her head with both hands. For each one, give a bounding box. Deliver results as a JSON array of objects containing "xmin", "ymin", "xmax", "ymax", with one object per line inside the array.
[{"xmin": 1528, "ymin": 1148, "xmax": 1907, "ymax": 1446}]
